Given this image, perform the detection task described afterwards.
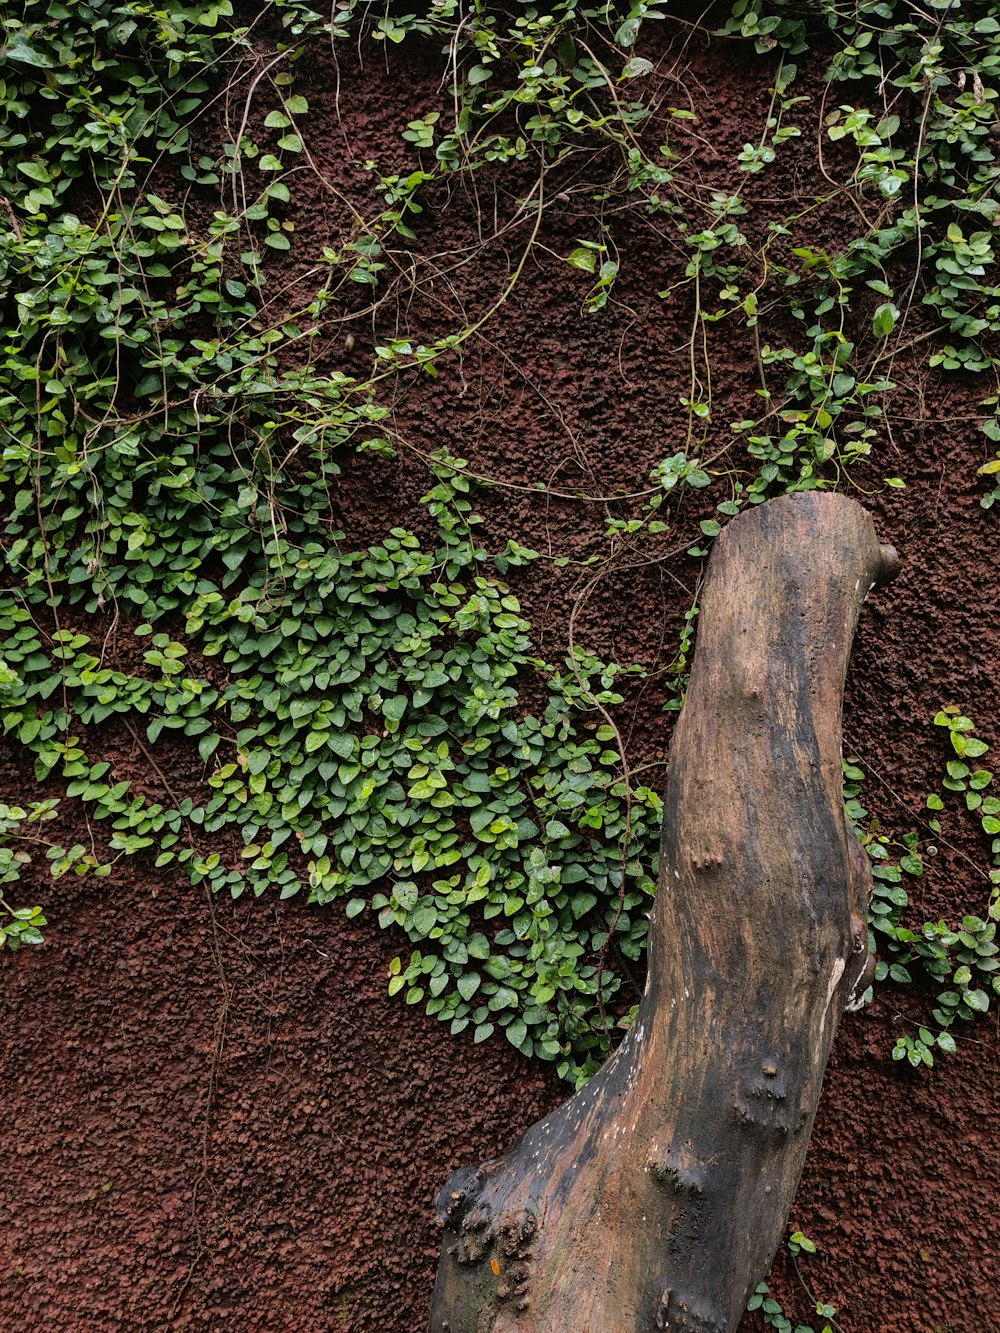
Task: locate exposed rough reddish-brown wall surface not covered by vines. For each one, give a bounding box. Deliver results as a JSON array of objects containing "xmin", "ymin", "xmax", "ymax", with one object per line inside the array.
[{"xmin": 0, "ymin": 12, "xmax": 1000, "ymax": 1333}]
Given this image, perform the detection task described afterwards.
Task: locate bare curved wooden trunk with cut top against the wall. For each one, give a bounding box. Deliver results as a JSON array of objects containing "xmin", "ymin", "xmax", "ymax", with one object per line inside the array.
[{"xmin": 431, "ymin": 492, "xmax": 899, "ymax": 1333}]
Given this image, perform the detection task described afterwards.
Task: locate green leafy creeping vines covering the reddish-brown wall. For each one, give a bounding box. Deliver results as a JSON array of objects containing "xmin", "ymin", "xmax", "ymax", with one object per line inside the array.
[{"xmin": 0, "ymin": 0, "xmax": 1000, "ymax": 1080}]
